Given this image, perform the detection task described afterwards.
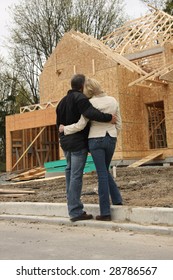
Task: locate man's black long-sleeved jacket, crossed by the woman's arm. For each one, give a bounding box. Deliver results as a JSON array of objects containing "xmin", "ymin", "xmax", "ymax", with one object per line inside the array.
[{"xmin": 56, "ymin": 90, "xmax": 112, "ymax": 152}]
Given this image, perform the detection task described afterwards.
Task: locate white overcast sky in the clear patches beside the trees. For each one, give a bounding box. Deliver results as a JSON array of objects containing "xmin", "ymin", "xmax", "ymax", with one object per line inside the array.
[{"xmin": 0, "ymin": 0, "xmax": 147, "ymax": 57}]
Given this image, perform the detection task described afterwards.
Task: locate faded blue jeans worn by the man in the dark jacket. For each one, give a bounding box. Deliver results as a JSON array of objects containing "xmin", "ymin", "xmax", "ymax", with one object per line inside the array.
[{"xmin": 64, "ymin": 149, "xmax": 88, "ymax": 218}]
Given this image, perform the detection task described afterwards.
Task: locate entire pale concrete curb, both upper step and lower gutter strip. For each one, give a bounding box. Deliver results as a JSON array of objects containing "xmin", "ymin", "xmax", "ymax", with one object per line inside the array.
[{"xmin": 0, "ymin": 202, "xmax": 173, "ymax": 235}]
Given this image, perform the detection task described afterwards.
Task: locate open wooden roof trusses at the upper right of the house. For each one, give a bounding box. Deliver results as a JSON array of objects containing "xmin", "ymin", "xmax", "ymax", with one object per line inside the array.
[{"xmin": 102, "ymin": 7, "xmax": 173, "ymax": 55}]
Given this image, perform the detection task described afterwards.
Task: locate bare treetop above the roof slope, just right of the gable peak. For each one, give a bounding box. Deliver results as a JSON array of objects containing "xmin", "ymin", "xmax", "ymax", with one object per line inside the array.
[{"xmin": 69, "ymin": 0, "xmax": 125, "ymax": 39}]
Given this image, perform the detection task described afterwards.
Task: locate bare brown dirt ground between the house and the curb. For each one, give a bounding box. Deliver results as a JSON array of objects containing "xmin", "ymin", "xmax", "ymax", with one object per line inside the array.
[{"xmin": 0, "ymin": 166, "xmax": 173, "ymax": 208}]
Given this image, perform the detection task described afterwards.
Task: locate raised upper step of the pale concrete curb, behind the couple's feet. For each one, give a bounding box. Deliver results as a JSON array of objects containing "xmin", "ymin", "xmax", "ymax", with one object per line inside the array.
[{"xmin": 0, "ymin": 202, "xmax": 173, "ymax": 226}]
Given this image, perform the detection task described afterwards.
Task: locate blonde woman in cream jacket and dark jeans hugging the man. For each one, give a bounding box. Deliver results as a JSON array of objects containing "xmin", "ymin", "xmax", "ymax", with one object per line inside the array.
[{"xmin": 59, "ymin": 79, "xmax": 122, "ymax": 221}]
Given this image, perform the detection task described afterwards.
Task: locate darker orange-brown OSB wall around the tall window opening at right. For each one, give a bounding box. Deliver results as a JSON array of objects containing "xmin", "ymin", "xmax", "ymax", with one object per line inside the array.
[{"xmin": 119, "ymin": 61, "xmax": 173, "ymax": 159}]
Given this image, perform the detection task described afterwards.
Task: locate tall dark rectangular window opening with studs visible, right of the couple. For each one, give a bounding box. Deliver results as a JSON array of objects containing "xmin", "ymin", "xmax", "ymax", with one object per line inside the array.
[{"xmin": 147, "ymin": 101, "xmax": 167, "ymax": 149}]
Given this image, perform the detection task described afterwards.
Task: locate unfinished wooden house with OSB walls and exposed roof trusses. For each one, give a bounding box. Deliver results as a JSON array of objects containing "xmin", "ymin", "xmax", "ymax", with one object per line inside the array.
[{"xmin": 6, "ymin": 9, "xmax": 173, "ymax": 171}]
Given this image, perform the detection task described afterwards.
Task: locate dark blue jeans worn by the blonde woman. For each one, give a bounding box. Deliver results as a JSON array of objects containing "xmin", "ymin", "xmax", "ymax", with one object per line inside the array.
[{"xmin": 89, "ymin": 133, "xmax": 122, "ymax": 216}]
